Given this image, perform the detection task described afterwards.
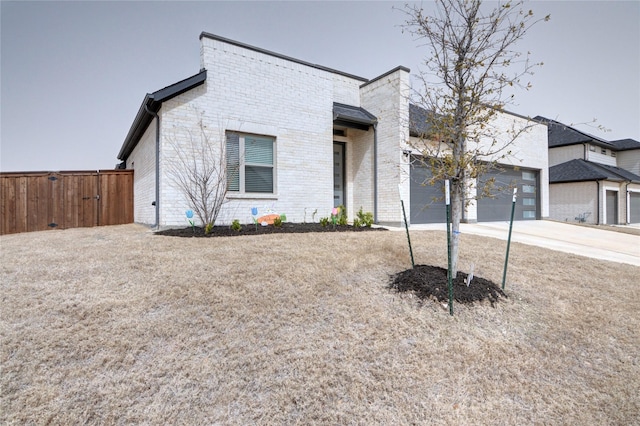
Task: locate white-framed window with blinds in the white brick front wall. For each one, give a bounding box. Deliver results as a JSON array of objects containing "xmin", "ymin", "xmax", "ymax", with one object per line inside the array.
[{"xmin": 227, "ymin": 132, "xmax": 276, "ymax": 194}]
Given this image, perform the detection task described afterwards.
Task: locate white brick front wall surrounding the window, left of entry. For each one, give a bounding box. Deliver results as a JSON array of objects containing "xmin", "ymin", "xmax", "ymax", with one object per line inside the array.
[{"xmin": 152, "ymin": 37, "xmax": 362, "ymax": 226}]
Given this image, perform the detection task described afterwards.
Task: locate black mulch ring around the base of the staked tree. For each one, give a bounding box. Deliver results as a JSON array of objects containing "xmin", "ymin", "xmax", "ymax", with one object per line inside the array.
[{"xmin": 389, "ymin": 265, "xmax": 507, "ymax": 306}]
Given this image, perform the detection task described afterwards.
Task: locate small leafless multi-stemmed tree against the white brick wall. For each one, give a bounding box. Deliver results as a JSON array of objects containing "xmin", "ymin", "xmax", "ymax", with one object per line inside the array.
[{"xmin": 167, "ymin": 118, "xmax": 238, "ymax": 231}]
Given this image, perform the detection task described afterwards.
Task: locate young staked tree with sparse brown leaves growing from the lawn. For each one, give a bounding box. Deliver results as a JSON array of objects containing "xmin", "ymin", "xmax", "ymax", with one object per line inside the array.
[{"xmin": 403, "ymin": 0, "xmax": 549, "ymax": 277}]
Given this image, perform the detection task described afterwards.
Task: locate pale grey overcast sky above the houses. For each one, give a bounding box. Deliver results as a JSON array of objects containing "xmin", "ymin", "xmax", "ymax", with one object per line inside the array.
[{"xmin": 0, "ymin": 1, "xmax": 640, "ymax": 171}]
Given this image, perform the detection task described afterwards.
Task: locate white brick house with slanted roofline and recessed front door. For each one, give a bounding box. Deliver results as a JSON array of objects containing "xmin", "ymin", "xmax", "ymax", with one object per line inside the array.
[{"xmin": 118, "ymin": 33, "xmax": 548, "ymax": 227}]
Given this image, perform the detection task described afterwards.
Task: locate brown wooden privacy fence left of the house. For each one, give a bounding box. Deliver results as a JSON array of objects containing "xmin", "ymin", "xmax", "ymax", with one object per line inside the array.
[{"xmin": 0, "ymin": 170, "xmax": 133, "ymax": 235}]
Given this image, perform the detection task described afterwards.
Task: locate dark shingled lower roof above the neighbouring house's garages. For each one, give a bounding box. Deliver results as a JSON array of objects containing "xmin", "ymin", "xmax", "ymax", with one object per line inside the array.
[{"xmin": 549, "ymin": 159, "xmax": 640, "ymax": 183}]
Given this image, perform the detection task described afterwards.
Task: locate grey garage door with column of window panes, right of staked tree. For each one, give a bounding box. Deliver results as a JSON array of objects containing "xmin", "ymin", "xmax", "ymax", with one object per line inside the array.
[{"xmin": 478, "ymin": 166, "xmax": 540, "ymax": 222}]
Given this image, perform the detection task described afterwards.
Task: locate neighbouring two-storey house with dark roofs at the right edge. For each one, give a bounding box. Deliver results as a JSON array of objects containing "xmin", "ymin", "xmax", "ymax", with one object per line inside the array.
[{"xmin": 535, "ymin": 116, "xmax": 640, "ymax": 225}]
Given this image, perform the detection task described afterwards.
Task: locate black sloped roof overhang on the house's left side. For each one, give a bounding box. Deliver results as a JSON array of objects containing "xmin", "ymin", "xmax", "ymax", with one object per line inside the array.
[{"xmin": 118, "ymin": 70, "xmax": 207, "ymax": 161}]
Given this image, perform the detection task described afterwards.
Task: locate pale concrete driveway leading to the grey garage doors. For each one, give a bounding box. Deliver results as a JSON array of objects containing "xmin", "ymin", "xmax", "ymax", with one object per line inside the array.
[{"xmin": 388, "ymin": 220, "xmax": 640, "ymax": 266}]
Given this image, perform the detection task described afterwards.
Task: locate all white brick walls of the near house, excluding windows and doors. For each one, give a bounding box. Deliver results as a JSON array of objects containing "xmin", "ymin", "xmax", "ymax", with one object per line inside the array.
[{"xmin": 128, "ymin": 37, "xmax": 549, "ymax": 227}]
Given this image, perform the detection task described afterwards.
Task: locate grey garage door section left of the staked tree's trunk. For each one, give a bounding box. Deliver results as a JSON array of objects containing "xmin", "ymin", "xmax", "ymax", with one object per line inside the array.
[{"xmin": 409, "ymin": 164, "xmax": 447, "ymax": 224}]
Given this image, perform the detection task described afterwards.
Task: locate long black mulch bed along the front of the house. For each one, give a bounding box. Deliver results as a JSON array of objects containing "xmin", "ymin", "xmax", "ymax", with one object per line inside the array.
[{"xmin": 156, "ymin": 223, "xmax": 386, "ymax": 237}]
